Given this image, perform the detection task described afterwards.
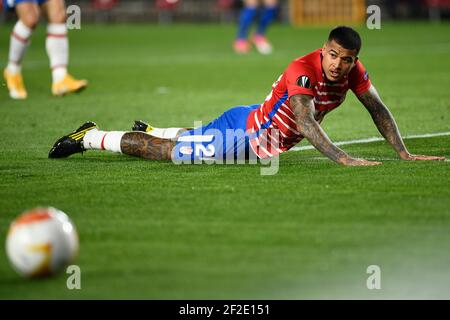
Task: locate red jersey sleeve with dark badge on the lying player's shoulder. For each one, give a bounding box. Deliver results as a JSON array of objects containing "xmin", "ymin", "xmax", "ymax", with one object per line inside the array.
[{"xmin": 284, "ymin": 61, "xmax": 316, "ymax": 98}]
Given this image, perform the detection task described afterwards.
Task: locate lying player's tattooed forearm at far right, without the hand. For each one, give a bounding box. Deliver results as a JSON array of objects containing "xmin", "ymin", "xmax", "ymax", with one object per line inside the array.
[{"xmin": 358, "ymin": 86, "xmax": 407, "ymax": 155}]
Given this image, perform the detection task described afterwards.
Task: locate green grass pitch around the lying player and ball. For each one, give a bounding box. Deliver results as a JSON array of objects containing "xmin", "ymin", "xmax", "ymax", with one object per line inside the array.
[{"xmin": 0, "ymin": 24, "xmax": 450, "ymax": 299}]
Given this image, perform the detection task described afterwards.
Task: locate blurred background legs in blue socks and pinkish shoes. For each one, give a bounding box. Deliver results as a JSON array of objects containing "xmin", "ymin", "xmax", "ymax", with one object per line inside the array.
[{"xmin": 234, "ymin": 0, "xmax": 278, "ymax": 54}]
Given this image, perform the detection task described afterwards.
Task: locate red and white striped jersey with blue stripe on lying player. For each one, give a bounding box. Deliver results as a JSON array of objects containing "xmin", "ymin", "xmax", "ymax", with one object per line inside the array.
[{"xmin": 247, "ymin": 49, "xmax": 371, "ymax": 158}]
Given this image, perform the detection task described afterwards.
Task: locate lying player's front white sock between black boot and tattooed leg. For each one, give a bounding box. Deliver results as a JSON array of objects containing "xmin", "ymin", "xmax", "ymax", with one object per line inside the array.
[{"xmin": 83, "ymin": 129, "xmax": 126, "ymax": 153}]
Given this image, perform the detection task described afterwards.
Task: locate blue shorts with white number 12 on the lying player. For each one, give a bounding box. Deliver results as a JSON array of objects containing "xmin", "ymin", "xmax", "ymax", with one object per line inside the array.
[{"xmin": 173, "ymin": 104, "xmax": 260, "ymax": 163}]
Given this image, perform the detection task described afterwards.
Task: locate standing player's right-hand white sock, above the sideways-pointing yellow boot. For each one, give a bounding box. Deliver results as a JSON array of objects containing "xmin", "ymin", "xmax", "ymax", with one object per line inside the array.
[{"xmin": 45, "ymin": 23, "xmax": 69, "ymax": 83}]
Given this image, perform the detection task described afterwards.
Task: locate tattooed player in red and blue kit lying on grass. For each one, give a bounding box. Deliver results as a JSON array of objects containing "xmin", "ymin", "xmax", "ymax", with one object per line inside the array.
[{"xmin": 49, "ymin": 26, "xmax": 444, "ymax": 166}]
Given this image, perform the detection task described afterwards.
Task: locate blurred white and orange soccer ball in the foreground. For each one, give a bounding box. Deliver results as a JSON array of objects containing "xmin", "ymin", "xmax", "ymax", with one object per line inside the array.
[{"xmin": 6, "ymin": 208, "xmax": 78, "ymax": 277}]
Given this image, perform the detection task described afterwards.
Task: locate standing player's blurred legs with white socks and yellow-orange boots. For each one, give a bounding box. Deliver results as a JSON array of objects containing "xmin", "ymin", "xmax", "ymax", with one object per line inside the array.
[{"xmin": 4, "ymin": 0, "xmax": 87, "ymax": 99}]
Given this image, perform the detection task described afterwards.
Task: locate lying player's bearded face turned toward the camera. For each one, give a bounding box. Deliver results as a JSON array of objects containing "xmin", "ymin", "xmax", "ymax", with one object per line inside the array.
[{"xmin": 322, "ymin": 40, "xmax": 358, "ymax": 81}]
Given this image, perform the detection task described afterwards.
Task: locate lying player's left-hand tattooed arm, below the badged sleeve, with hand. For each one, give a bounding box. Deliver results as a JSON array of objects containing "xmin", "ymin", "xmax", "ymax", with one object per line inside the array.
[{"xmin": 290, "ymin": 94, "xmax": 380, "ymax": 165}]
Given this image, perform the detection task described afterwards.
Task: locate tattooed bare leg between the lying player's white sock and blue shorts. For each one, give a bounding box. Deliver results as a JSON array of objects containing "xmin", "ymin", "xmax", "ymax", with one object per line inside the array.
[{"xmin": 120, "ymin": 131, "xmax": 175, "ymax": 160}]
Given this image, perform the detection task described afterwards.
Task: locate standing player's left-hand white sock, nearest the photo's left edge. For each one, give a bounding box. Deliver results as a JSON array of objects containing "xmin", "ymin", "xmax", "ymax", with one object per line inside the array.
[{"xmin": 6, "ymin": 20, "xmax": 33, "ymax": 74}]
